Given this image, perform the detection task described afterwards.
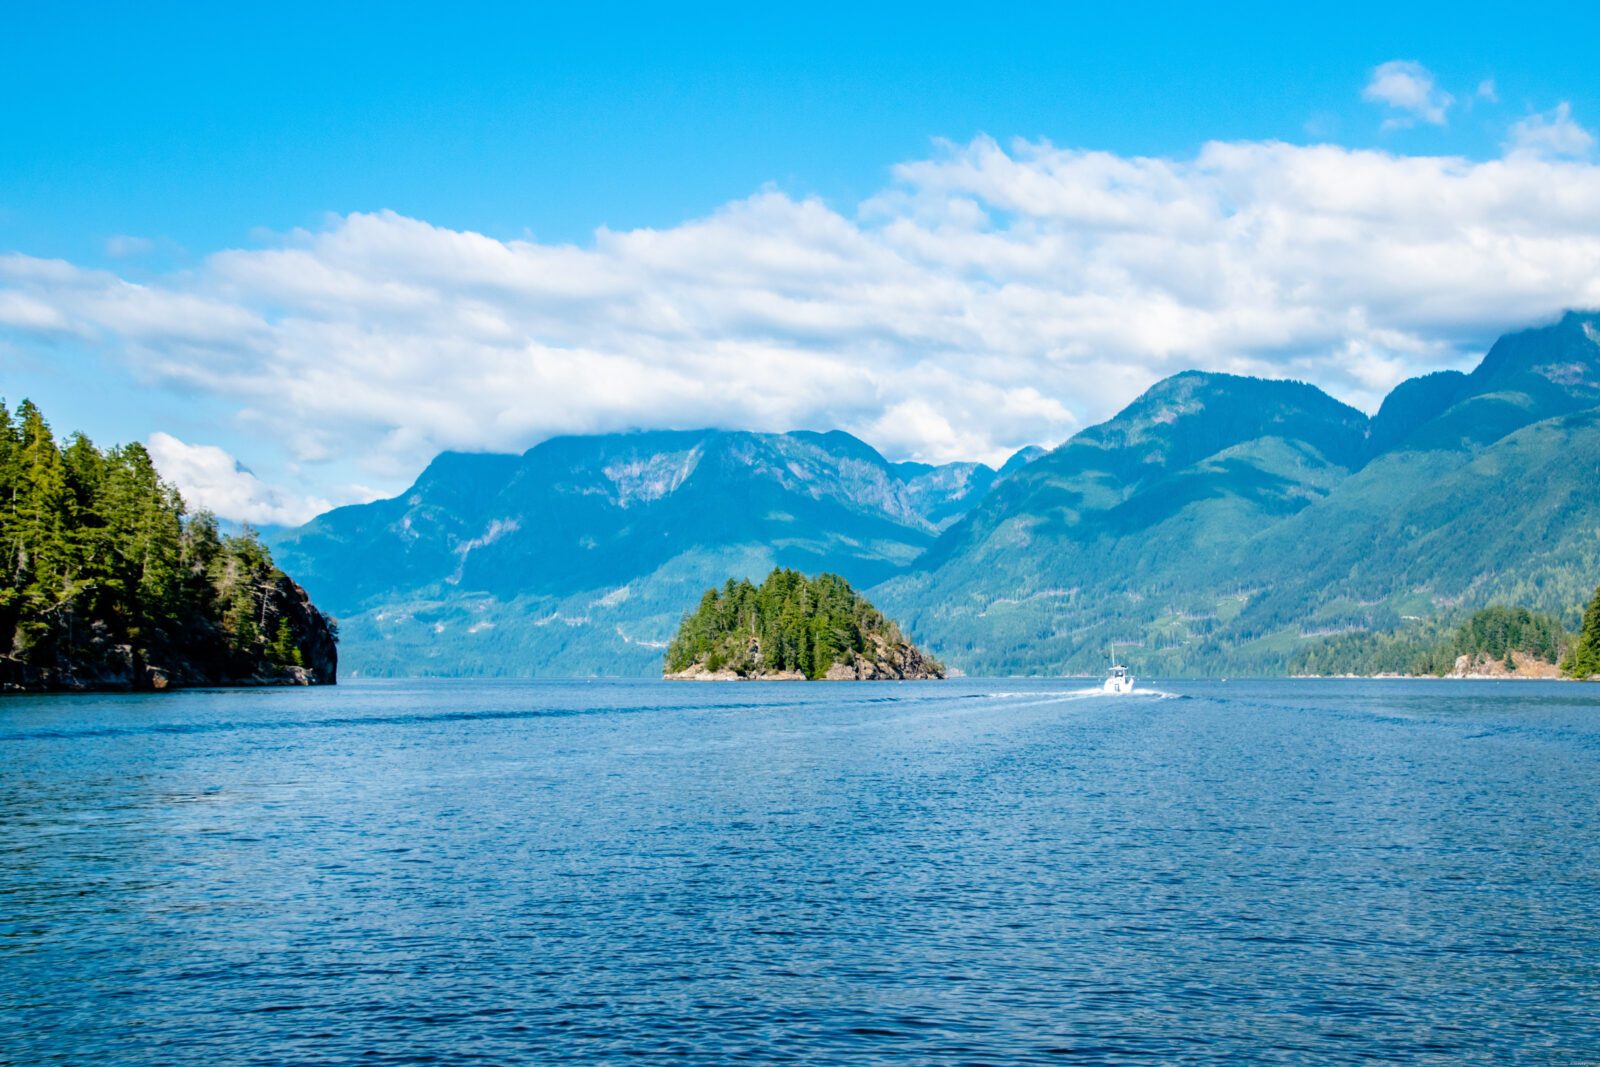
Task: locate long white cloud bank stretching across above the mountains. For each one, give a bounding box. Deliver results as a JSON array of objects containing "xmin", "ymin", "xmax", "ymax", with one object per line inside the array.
[{"xmin": 9, "ymin": 135, "xmax": 1600, "ymax": 522}]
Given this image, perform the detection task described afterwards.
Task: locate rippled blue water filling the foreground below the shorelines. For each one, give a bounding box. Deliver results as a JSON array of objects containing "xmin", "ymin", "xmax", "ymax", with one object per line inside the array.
[{"xmin": 0, "ymin": 681, "xmax": 1600, "ymax": 1065}]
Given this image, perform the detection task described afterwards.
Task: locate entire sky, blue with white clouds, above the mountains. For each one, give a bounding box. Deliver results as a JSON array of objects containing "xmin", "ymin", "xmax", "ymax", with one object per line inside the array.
[{"xmin": 0, "ymin": 3, "xmax": 1600, "ymax": 518}]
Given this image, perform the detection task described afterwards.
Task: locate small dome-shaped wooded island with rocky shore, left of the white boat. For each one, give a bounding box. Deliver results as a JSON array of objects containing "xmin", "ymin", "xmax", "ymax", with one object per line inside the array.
[{"xmin": 662, "ymin": 568, "xmax": 944, "ymax": 681}]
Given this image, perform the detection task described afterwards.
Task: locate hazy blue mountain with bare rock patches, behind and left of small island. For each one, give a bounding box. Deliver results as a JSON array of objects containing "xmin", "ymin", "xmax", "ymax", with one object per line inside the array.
[{"xmin": 270, "ymin": 430, "xmax": 995, "ymax": 675}]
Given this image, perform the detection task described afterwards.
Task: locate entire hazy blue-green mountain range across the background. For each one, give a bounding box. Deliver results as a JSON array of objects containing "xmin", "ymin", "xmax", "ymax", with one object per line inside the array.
[{"xmin": 272, "ymin": 312, "xmax": 1600, "ymax": 675}]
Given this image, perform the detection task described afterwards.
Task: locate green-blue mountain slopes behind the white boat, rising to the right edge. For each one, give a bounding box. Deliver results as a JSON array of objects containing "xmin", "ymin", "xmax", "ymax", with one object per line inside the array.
[{"xmin": 874, "ymin": 314, "xmax": 1600, "ymax": 672}]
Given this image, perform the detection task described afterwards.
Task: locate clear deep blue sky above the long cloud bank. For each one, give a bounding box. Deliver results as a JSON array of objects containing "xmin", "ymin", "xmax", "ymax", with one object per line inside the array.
[{"xmin": 9, "ymin": 3, "xmax": 1600, "ymax": 261}]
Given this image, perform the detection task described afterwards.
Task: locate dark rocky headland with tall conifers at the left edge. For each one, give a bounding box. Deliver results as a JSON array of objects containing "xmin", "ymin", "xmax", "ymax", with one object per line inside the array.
[{"xmin": 0, "ymin": 400, "xmax": 338, "ymax": 691}]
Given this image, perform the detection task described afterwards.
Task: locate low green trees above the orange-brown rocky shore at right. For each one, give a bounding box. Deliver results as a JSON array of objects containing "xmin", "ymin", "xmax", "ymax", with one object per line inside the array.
[{"xmin": 1290, "ymin": 605, "xmax": 1568, "ymax": 675}]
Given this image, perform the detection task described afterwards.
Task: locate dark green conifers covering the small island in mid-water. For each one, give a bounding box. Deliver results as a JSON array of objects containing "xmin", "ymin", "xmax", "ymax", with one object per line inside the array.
[{"xmin": 667, "ymin": 568, "xmax": 934, "ymax": 678}]
